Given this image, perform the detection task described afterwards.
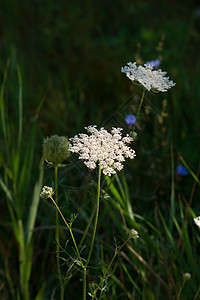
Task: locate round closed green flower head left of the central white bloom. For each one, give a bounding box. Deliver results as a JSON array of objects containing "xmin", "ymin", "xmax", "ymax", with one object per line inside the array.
[{"xmin": 43, "ymin": 134, "xmax": 69, "ymax": 167}]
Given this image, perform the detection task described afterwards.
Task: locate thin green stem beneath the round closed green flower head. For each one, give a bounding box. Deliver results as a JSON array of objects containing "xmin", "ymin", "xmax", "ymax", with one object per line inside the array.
[{"xmin": 55, "ymin": 166, "xmax": 64, "ymax": 300}]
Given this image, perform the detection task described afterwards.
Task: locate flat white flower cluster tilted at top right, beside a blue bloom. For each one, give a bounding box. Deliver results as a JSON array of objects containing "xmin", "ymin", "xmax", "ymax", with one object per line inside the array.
[{"xmin": 121, "ymin": 62, "xmax": 176, "ymax": 92}]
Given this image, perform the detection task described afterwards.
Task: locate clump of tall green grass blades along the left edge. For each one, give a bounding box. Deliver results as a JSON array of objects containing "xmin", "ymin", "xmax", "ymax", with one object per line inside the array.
[{"xmin": 0, "ymin": 61, "xmax": 43, "ymax": 300}]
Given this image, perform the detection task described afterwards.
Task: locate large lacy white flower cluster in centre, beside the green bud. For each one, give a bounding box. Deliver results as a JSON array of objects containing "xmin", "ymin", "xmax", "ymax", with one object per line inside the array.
[{"xmin": 69, "ymin": 125, "xmax": 136, "ymax": 176}]
